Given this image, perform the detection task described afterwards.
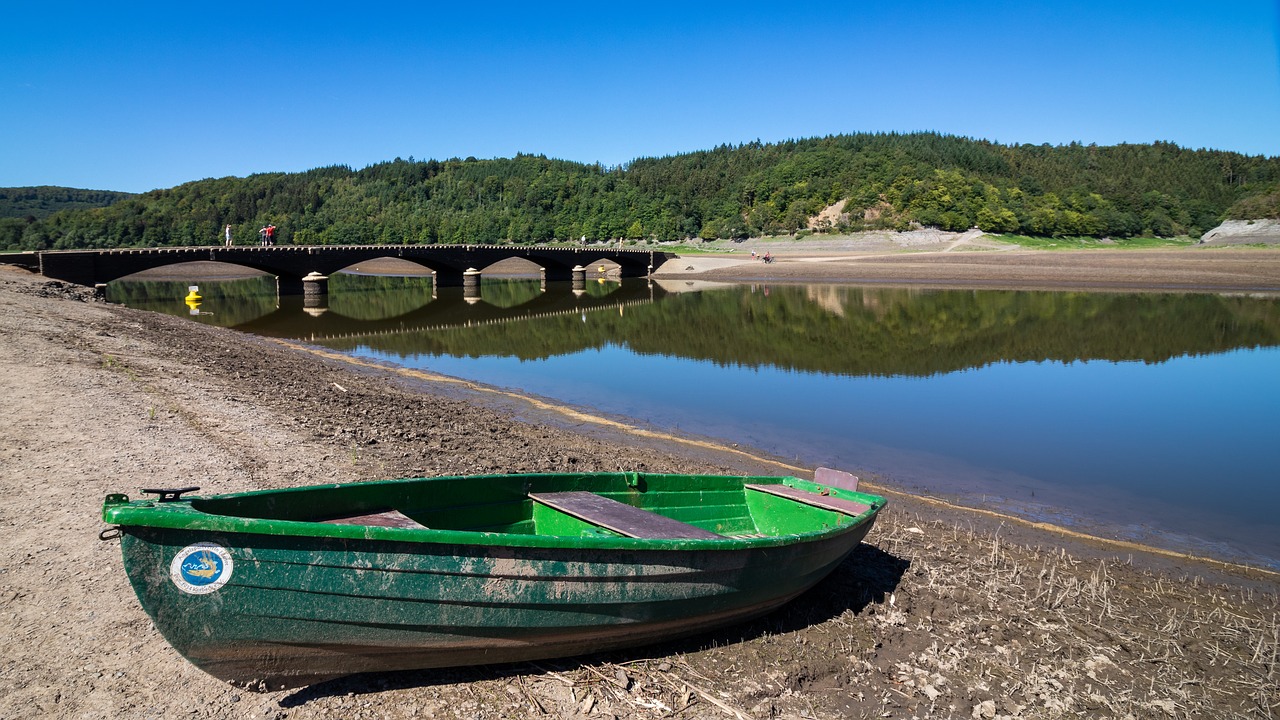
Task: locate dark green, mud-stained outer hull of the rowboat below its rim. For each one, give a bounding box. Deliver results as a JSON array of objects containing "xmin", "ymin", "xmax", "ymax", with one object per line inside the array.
[{"xmin": 122, "ymin": 523, "xmax": 870, "ymax": 689}]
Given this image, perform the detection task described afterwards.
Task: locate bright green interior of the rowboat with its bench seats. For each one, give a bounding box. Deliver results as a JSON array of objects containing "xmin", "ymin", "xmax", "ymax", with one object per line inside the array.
[{"xmin": 192, "ymin": 473, "xmax": 878, "ymax": 539}]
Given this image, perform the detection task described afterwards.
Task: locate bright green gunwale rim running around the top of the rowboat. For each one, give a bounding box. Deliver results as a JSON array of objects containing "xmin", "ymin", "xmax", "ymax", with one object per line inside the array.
[{"xmin": 102, "ymin": 473, "xmax": 886, "ymax": 551}]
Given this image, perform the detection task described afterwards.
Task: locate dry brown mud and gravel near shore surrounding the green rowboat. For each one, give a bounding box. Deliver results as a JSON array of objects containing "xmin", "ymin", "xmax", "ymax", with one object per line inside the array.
[{"xmin": 0, "ymin": 243, "xmax": 1280, "ymax": 719}]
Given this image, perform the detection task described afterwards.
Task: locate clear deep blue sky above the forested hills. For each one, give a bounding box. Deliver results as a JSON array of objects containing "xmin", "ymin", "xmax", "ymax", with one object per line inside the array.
[{"xmin": 0, "ymin": 0, "xmax": 1280, "ymax": 192}]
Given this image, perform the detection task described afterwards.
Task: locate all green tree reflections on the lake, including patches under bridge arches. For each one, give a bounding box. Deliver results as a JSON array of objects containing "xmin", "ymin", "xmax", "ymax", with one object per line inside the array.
[{"xmin": 108, "ymin": 273, "xmax": 1280, "ymax": 375}]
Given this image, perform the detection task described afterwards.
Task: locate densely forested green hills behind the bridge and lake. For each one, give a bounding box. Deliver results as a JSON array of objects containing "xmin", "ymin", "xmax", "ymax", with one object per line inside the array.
[{"xmin": 0, "ymin": 133, "xmax": 1280, "ymax": 250}]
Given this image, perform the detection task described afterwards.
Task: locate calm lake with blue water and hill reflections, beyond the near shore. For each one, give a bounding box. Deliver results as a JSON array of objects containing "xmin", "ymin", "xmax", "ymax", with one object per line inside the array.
[{"xmin": 108, "ymin": 274, "xmax": 1280, "ymax": 569}]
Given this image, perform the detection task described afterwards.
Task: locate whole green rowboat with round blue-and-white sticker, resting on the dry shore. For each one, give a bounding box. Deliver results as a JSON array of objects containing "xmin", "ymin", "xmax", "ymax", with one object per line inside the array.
[{"xmin": 102, "ymin": 469, "xmax": 884, "ymax": 689}]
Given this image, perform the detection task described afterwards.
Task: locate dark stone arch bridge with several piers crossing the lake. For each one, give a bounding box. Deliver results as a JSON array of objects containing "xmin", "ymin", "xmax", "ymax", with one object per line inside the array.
[{"xmin": 15, "ymin": 245, "xmax": 676, "ymax": 295}]
